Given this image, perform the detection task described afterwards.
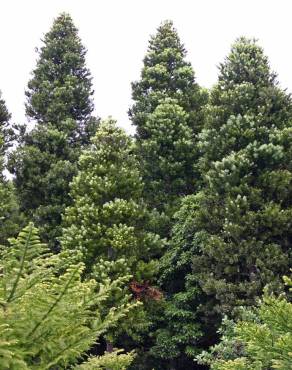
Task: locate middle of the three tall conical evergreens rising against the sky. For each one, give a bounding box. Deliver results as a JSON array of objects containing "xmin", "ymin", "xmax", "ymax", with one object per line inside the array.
[{"xmin": 129, "ymin": 21, "xmax": 206, "ymax": 224}]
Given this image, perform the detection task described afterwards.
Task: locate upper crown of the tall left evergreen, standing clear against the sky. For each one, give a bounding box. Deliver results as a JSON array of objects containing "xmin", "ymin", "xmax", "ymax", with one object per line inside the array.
[{"xmin": 26, "ymin": 13, "xmax": 93, "ymax": 123}]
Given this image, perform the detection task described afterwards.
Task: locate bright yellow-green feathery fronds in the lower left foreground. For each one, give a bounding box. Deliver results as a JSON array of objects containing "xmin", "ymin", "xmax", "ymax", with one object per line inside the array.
[{"xmin": 0, "ymin": 224, "xmax": 134, "ymax": 369}]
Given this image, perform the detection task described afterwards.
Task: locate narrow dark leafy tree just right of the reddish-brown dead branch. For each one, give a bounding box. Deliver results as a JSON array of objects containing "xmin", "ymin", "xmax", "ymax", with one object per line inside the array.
[{"xmin": 152, "ymin": 195, "xmax": 206, "ymax": 369}]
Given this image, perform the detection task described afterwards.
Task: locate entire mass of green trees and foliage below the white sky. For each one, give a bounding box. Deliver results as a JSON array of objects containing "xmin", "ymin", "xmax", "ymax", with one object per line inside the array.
[{"xmin": 0, "ymin": 13, "xmax": 292, "ymax": 370}]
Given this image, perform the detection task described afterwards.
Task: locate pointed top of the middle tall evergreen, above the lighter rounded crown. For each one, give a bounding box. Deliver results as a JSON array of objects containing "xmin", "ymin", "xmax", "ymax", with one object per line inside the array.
[{"xmin": 129, "ymin": 21, "xmax": 205, "ymax": 138}]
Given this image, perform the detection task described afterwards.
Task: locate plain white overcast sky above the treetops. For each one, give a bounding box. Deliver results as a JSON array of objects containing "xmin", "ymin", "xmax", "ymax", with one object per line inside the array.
[{"xmin": 0, "ymin": 0, "xmax": 292, "ymax": 131}]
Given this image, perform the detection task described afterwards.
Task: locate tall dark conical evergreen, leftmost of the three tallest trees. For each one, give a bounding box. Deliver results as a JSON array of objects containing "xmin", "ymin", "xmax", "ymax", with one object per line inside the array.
[{"xmin": 9, "ymin": 14, "xmax": 97, "ymax": 247}]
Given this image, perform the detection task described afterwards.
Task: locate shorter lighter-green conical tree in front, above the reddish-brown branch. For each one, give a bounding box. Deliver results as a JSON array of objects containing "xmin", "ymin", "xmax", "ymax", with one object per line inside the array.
[{"xmin": 62, "ymin": 119, "xmax": 161, "ymax": 281}]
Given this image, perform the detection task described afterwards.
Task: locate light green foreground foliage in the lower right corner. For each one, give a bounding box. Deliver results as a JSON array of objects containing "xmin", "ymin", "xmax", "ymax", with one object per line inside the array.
[{"xmin": 199, "ymin": 278, "xmax": 292, "ymax": 370}]
